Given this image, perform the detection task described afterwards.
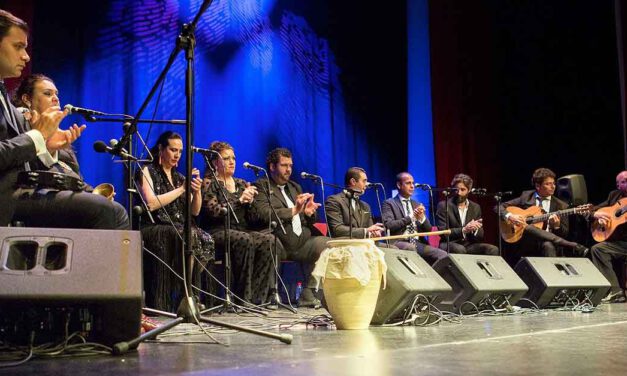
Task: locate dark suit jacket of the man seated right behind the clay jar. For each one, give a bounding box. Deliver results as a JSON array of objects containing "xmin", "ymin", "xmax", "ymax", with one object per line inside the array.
[{"xmin": 324, "ymin": 192, "xmax": 374, "ymax": 239}]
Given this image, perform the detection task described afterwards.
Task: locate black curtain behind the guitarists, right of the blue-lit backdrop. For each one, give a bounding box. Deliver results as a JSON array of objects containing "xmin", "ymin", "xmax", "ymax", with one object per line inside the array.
[{"xmin": 430, "ymin": 0, "xmax": 623, "ymax": 241}]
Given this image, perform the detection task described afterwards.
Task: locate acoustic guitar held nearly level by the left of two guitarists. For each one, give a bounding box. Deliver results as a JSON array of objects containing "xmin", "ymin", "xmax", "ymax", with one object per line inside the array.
[{"xmin": 499, "ymin": 204, "xmax": 592, "ymax": 243}]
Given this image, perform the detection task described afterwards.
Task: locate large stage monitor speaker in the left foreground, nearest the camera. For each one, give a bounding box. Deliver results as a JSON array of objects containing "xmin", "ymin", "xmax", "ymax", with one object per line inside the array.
[{"xmin": 0, "ymin": 227, "xmax": 142, "ymax": 345}]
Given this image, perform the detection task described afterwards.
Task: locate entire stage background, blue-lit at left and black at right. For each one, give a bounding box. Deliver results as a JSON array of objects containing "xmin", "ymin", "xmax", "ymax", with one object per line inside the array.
[{"xmin": 0, "ymin": 0, "xmax": 625, "ymax": 241}]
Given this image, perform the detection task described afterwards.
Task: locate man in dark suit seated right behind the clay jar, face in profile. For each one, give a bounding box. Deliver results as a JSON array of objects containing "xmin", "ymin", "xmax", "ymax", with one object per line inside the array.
[{"xmin": 324, "ymin": 167, "xmax": 384, "ymax": 239}]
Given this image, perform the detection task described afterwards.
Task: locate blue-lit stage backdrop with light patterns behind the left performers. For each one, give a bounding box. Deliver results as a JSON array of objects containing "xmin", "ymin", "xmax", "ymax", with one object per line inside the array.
[{"xmin": 24, "ymin": 0, "xmax": 420, "ymax": 219}]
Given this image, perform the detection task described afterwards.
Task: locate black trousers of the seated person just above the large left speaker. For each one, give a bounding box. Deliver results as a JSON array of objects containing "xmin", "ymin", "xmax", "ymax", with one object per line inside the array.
[{"xmin": 13, "ymin": 189, "xmax": 130, "ymax": 230}]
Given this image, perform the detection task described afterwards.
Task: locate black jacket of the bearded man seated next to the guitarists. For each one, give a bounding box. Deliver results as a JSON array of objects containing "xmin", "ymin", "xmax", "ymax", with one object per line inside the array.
[{"xmin": 435, "ymin": 197, "xmax": 483, "ymax": 243}]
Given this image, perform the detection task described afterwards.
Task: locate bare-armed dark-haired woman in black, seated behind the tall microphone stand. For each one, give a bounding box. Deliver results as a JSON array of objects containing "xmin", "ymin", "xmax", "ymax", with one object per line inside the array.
[{"xmin": 139, "ymin": 131, "xmax": 214, "ymax": 311}]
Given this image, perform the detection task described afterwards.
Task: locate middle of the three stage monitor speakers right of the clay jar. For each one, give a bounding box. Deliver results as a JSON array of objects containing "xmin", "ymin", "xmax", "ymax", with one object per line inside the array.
[{"xmin": 433, "ymin": 254, "xmax": 528, "ymax": 314}]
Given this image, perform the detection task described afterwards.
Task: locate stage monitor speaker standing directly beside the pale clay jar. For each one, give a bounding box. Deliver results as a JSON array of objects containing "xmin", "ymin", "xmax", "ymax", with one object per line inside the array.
[{"xmin": 372, "ymin": 248, "xmax": 452, "ymax": 325}]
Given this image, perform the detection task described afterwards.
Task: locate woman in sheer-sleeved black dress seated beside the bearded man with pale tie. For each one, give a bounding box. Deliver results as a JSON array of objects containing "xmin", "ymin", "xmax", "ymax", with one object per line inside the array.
[{"xmin": 201, "ymin": 141, "xmax": 283, "ymax": 303}]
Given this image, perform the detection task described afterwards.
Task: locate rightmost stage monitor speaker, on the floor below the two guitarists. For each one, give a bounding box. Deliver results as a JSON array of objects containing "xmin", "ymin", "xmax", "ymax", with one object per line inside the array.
[{"xmin": 515, "ymin": 257, "xmax": 610, "ymax": 308}]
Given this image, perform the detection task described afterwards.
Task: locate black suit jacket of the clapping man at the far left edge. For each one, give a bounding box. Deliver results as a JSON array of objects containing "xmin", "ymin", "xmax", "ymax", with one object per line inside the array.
[{"xmin": 0, "ymin": 103, "xmax": 37, "ymax": 226}]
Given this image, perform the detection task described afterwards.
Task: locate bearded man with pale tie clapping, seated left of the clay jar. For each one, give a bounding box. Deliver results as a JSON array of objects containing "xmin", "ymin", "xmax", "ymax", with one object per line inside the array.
[{"xmin": 253, "ymin": 148, "xmax": 329, "ymax": 307}]
